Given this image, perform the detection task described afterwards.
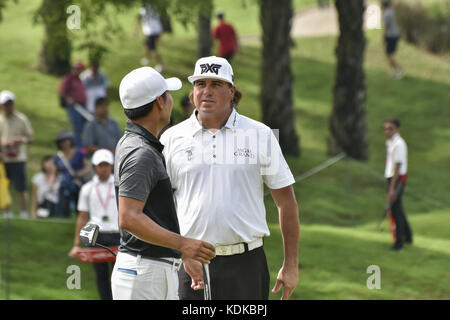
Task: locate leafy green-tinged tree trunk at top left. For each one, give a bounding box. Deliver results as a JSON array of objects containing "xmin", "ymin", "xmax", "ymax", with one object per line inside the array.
[{"xmin": 36, "ymin": 0, "xmax": 72, "ymax": 75}]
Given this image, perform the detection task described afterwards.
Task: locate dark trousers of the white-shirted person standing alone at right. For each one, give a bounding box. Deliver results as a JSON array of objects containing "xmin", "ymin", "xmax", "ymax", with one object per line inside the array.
[{"xmin": 388, "ymin": 179, "xmax": 412, "ymax": 248}]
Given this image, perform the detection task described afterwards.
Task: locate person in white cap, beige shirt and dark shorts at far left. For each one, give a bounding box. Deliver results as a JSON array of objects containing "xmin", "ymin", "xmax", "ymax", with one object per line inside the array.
[{"xmin": 0, "ymin": 90, "xmax": 33, "ymax": 218}]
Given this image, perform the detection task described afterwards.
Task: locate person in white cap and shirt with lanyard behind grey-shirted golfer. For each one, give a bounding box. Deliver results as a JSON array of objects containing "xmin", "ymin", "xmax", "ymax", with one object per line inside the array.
[{"xmin": 69, "ymin": 149, "xmax": 120, "ymax": 300}]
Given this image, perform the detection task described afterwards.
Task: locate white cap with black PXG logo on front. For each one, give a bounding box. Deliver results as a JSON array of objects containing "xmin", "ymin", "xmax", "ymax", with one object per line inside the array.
[{"xmin": 188, "ymin": 56, "xmax": 234, "ymax": 85}]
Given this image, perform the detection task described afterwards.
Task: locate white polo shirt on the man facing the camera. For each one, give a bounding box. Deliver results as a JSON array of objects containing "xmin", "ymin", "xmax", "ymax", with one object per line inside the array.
[{"xmin": 160, "ymin": 109, "xmax": 295, "ymax": 245}]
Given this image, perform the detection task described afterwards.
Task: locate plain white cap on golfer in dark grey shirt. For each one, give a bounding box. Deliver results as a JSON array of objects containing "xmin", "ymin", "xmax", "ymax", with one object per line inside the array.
[{"xmin": 119, "ymin": 67, "xmax": 182, "ymax": 109}]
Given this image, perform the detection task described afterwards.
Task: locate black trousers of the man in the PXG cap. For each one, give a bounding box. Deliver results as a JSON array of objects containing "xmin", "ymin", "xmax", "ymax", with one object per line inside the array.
[{"xmin": 178, "ymin": 247, "xmax": 270, "ymax": 300}]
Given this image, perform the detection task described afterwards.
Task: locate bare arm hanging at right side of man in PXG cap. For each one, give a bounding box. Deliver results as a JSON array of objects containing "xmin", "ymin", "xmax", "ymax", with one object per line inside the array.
[{"xmin": 270, "ymin": 186, "xmax": 300, "ymax": 300}]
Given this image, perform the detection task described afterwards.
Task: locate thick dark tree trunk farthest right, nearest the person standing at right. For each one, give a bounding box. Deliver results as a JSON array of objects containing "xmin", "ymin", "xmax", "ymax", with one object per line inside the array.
[{"xmin": 328, "ymin": 0, "xmax": 368, "ymax": 160}]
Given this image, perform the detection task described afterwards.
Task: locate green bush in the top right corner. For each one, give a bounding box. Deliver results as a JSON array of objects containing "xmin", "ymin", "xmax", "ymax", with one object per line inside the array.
[{"xmin": 394, "ymin": 2, "xmax": 450, "ymax": 53}]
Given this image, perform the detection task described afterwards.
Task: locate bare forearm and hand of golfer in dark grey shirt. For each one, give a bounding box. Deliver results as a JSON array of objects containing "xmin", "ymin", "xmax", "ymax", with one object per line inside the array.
[{"xmin": 119, "ymin": 196, "xmax": 215, "ymax": 263}]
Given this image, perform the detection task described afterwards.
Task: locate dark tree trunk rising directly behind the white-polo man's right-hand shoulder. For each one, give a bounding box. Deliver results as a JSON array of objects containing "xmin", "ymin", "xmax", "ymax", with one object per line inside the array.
[{"xmin": 260, "ymin": 0, "xmax": 300, "ymax": 156}]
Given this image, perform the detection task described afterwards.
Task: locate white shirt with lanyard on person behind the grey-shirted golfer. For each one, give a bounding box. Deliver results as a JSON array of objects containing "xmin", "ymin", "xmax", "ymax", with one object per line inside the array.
[{"xmin": 77, "ymin": 175, "xmax": 119, "ymax": 232}]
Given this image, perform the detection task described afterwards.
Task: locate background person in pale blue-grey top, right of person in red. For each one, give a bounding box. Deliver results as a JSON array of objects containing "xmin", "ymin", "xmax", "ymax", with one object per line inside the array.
[{"xmin": 80, "ymin": 62, "xmax": 109, "ymax": 113}]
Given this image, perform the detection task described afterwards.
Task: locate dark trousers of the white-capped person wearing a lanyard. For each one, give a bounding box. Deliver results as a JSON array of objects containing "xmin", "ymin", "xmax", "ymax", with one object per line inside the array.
[{"xmin": 92, "ymin": 232, "xmax": 120, "ymax": 300}]
